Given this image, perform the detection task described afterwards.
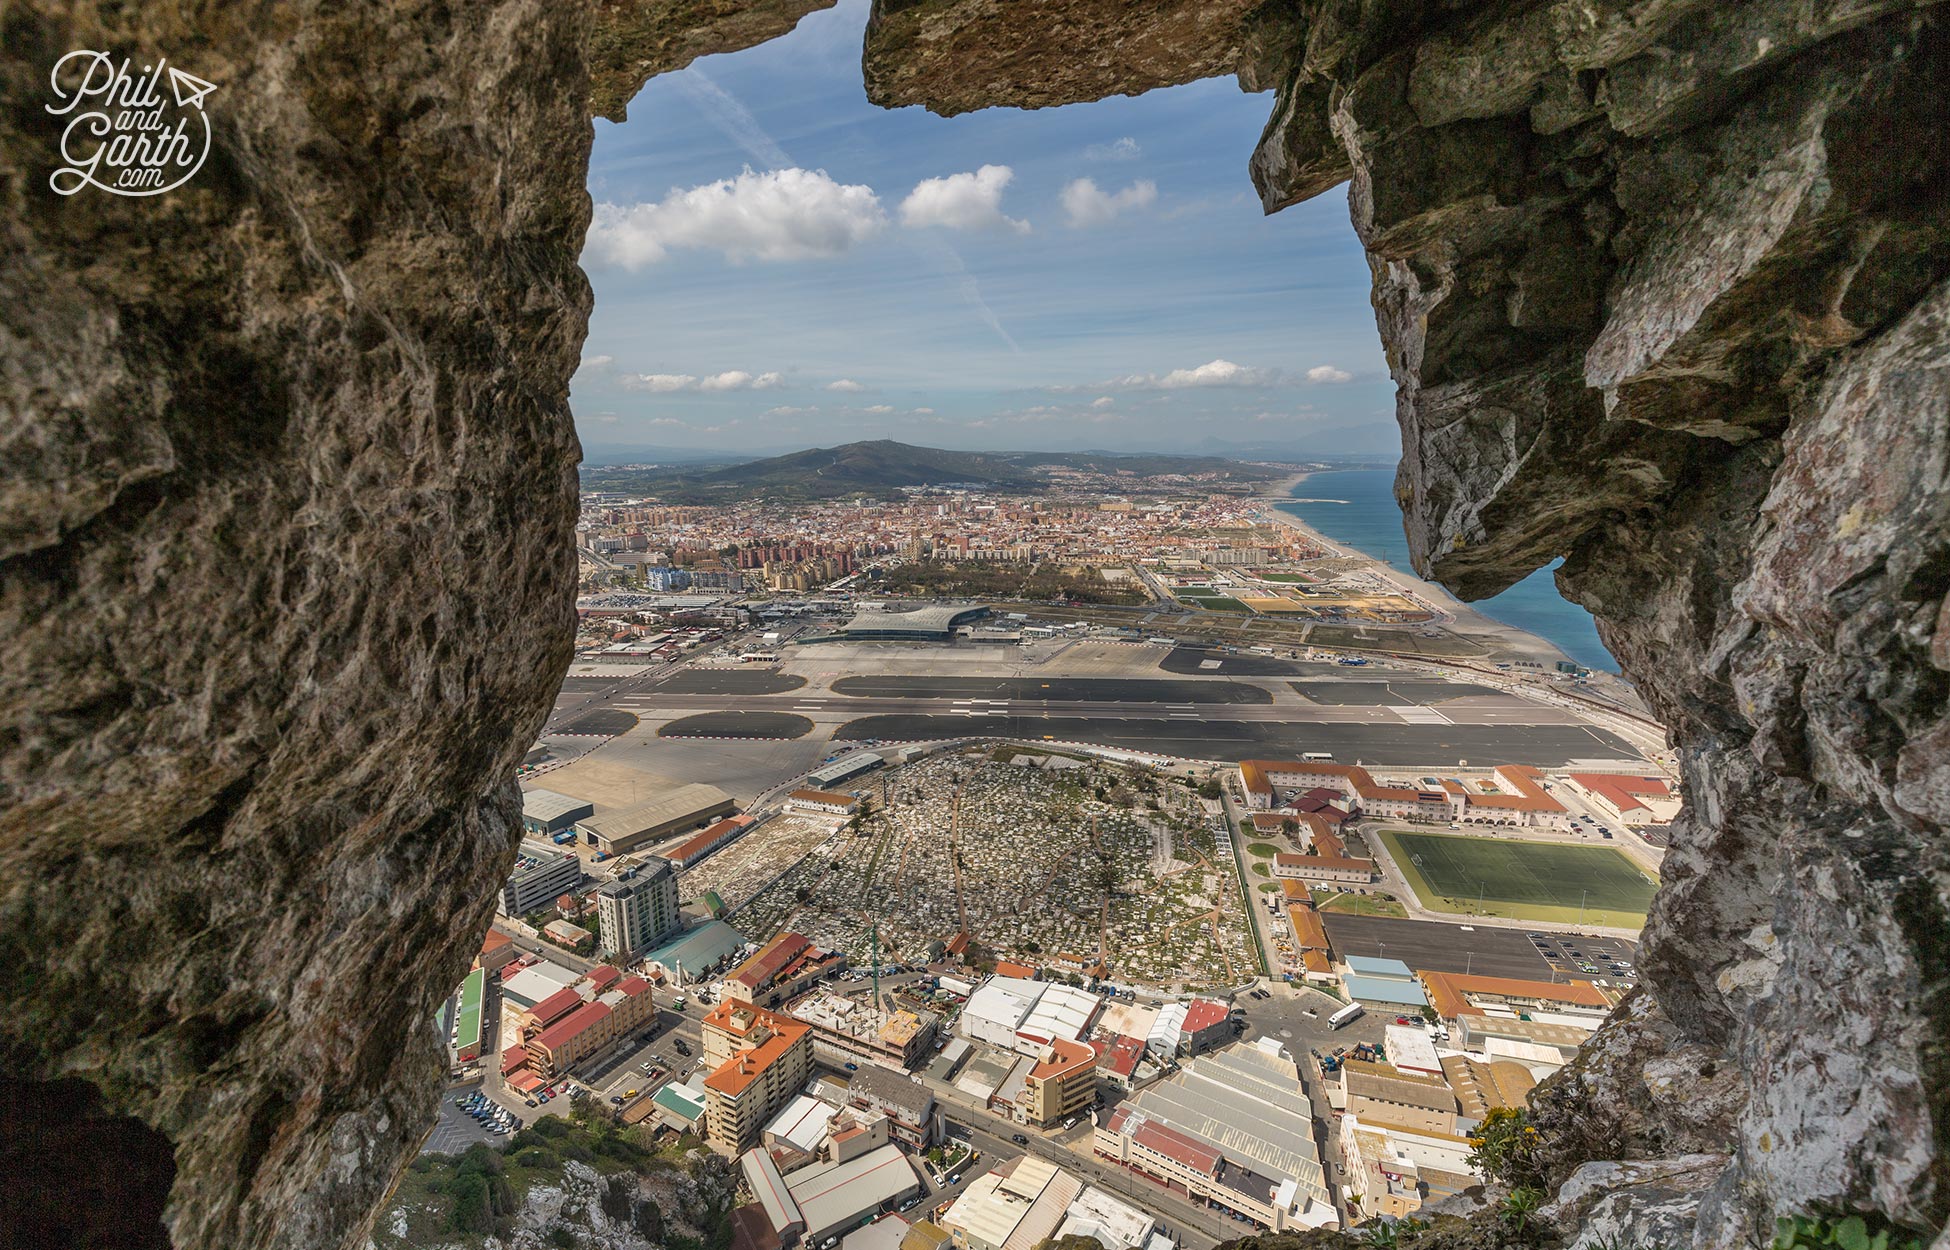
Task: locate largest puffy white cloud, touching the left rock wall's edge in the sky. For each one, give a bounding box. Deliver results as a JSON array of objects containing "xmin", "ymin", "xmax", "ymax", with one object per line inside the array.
[{"xmin": 587, "ymin": 168, "xmax": 887, "ymax": 269}]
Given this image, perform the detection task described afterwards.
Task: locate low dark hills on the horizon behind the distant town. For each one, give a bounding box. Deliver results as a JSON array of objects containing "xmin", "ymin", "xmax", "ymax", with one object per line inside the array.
[{"xmin": 583, "ymin": 439, "xmax": 1279, "ymax": 503}]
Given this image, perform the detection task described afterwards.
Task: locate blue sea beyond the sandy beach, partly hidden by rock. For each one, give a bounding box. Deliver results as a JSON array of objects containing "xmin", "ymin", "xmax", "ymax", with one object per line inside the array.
[{"xmin": 1279, "ymin": 468, "xmax": 1619, "ymax": 673}]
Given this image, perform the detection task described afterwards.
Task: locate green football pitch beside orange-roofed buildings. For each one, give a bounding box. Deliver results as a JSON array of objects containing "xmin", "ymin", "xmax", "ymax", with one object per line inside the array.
[{"xmin": 1381, "ymin": 829, "xmax": 1659, "ymax": 928}]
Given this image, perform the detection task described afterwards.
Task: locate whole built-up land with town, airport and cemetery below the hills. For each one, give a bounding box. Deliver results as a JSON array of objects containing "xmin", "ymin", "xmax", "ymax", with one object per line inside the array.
[{"xmin": 378, "ymin": 475, "xmax": 1679, "ymax": 1250}]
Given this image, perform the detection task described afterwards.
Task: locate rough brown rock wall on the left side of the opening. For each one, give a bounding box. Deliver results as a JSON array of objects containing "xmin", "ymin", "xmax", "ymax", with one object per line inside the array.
[{"xmin": 0, "ymin": 0, "xmax": 591, "ymax": 1250}]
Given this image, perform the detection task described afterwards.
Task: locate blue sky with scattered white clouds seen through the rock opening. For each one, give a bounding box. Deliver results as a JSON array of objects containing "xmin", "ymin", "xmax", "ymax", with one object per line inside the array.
[{"xmin": 573, "ymin": 0, "xmax": 1396, "ymax": 454}]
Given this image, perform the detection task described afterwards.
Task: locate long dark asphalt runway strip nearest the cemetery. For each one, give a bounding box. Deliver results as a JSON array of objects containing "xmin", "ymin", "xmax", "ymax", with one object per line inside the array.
[{"xmin": 833, "ymin": 708, "xmax": 1640, "ymax": 768}]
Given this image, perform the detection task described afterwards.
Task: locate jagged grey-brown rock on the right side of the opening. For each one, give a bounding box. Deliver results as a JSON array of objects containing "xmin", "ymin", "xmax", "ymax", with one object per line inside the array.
[{"xmin": 868, "ymin": 0, "xmax": 1950, "ymax": 1246}]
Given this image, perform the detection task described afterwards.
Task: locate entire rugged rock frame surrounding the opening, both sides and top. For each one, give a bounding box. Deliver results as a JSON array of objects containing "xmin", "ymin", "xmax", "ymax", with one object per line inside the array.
[{"xmin": 0, "ymin": 0, "xmax": 1950, "ymax": 1250}]
